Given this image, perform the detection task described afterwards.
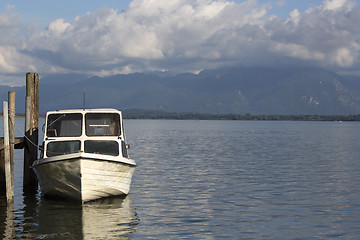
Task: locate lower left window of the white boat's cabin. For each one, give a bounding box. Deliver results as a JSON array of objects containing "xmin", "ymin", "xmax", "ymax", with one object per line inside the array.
[{"xmin": 46, "ymin": 141, "xmax": 80, "ymax": 157}]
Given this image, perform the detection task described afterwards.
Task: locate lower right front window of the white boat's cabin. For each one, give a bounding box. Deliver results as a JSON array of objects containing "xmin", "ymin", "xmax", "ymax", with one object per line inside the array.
[{"xmin": 84, "ymin": 140, "xmax": 119, "ymax": 156}]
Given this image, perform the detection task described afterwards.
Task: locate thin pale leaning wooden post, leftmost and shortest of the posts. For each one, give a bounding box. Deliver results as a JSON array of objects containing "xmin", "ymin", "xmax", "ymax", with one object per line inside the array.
[{"xmin": 3, "ymin": 102, "xmax": 14, "ymax": 203}]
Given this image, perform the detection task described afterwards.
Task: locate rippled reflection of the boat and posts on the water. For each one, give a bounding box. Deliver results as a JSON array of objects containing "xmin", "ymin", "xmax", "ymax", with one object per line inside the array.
[{"xmin": 0, "ymin": 196, "xmax": 139, "ymax": 239}]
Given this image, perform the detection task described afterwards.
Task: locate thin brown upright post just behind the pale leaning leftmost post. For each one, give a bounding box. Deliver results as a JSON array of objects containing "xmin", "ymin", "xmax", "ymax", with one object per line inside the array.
[{"xmin": 8, "ymin": 91, "xmax": 15, "ymax": 193}]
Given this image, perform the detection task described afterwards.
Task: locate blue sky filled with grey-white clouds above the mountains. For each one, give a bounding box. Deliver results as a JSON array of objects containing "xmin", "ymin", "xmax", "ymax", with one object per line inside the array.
[{"xmin": 0, "ymin": 0, "xmax": 360, "ymax": 86}]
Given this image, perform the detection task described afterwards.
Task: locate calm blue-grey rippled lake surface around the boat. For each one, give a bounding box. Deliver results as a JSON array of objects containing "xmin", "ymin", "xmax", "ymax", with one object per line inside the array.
[{"xmin": 0, "ymin": 119, "xmax": 360, "ymax": 239}]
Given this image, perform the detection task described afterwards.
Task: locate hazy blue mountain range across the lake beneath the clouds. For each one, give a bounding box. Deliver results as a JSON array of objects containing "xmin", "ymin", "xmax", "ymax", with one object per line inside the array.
[{"xmin": 0, "ymin": 67, "xmax": 360, "ymax": 115}]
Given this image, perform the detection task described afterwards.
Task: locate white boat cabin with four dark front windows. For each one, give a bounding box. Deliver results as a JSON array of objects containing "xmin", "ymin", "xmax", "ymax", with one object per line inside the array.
[{"xmin": 42, "ymin": 109, "xmax": 129, "ymax": 158}]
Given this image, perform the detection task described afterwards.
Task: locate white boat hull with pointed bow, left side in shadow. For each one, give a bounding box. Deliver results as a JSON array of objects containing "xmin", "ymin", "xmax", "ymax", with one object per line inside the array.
[{"xmin": 33, "ymin": 156, "xmax": 135, "ymax": 202}]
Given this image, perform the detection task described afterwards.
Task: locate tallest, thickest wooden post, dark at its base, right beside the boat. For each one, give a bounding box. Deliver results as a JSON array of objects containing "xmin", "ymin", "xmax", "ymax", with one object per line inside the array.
[{"xmin": 23, "ymin": 73, "xmax": 39, "ymax": 194}]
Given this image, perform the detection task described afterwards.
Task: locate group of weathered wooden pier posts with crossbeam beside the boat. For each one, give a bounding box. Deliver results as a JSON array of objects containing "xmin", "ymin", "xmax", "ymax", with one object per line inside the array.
[{"xmin": 0, "ymin": 73, "xmax": 39, "ymax": 199}]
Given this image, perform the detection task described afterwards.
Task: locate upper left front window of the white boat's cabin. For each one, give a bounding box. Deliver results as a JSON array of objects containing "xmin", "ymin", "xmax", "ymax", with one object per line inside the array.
[{"xmin": 46, "ymin": 113, "xmax": 82, "ymax": 137}]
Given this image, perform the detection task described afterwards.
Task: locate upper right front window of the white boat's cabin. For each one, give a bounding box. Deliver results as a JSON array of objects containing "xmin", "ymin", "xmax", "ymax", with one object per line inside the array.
[{"xmin": 85, "ymin": 113, "xmax": 120, "ymax": 136}]
